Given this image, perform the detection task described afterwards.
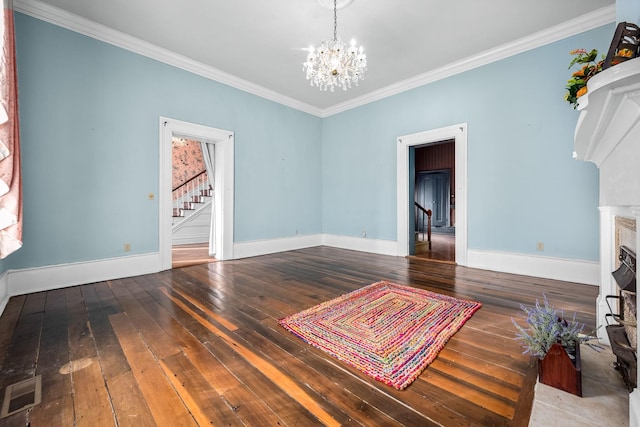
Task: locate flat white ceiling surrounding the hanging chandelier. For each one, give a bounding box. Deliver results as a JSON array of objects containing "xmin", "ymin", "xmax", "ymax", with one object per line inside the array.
[{"xmin": 23, "ymin": 0, "xmax": 615, "ymax": 114}]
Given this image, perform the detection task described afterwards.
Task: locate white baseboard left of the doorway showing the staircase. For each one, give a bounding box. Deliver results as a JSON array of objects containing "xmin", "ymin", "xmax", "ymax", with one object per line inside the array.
[{"xmin": 7, "ymin": 253, "xmax": 160, "ymax": 297}]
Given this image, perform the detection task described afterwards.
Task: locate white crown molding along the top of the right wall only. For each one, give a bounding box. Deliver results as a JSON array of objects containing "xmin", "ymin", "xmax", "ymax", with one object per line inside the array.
[{"xmin": 321, "ymin": 5, "xmax": 616, "ymax": 118}]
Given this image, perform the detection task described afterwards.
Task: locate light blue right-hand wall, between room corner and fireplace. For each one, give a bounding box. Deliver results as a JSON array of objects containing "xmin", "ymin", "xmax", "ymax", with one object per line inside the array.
[{"xmin": 322, "ymin": 25, "xmax": 614, "ymax": 260}]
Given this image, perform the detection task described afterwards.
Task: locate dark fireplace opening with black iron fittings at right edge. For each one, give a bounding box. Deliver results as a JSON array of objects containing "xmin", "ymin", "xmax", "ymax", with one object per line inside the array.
[{"xmin": 606, "ymin": 245, "xmax": 638, "ymax": 391}]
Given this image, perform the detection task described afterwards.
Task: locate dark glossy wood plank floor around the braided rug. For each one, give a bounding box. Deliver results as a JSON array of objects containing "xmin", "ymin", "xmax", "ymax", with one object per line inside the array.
[{"xmin": 0, "ymin": 247, "xmax": 597, "ymax": 426}]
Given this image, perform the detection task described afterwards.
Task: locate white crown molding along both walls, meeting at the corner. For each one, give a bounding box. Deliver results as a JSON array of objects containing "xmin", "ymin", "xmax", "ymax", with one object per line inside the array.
[{"xmin": 13, "ymin": 0, "xmax": 616, "ymax": 117}]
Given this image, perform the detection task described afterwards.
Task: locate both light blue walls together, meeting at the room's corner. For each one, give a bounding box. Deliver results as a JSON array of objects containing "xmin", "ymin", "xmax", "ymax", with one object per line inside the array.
[{"xmin": 7, "ymin": 13, "xmax": 613, "ymax": 270}]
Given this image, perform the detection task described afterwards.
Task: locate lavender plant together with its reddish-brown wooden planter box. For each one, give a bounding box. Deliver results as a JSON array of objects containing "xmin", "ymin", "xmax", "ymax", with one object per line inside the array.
[{"xmin": 511, "ymin": 296, "xmax": 591, "ymax": 396}]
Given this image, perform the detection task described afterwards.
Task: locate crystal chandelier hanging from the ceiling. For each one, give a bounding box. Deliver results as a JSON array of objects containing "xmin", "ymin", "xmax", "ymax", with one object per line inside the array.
[{"xmin": 303, "ymin": 0, "xmax": 367, "ymax": 92}]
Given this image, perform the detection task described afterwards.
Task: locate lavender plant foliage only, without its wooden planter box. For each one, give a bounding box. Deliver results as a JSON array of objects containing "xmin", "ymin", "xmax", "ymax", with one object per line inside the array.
[{"xmin": 511, "ymin": 295, "xmax": 584, "ymax": 359}]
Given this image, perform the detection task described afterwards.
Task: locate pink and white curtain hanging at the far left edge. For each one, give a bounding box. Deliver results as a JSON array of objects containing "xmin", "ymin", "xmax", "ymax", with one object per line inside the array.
[{"xmin": 0, "ymin": 0, "xmax": 22, "ymax": 258}]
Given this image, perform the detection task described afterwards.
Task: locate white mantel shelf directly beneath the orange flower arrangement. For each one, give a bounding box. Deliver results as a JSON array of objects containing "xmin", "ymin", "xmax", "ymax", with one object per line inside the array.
[{"xmin": 574, "ymin": 58, "xmax": 640, "ymax": 167}]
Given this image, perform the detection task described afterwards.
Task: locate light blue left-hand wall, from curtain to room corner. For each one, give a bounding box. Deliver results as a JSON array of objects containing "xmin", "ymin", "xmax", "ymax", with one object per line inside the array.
[{"xmin": 4, "ymin": 13, "xmax": 322, "ymax": 268}]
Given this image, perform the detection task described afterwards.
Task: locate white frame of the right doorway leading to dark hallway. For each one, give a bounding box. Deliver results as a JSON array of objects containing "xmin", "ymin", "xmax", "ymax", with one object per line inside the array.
[{"xmin": 396, "ymin": 123, "xmax": 467, "ymax": 265}]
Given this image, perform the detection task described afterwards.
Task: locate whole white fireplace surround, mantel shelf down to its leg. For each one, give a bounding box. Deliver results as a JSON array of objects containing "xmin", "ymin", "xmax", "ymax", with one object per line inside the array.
[{"xmin": 574, "ymin": 58, "xmax": 640, "ymax": 426}]
